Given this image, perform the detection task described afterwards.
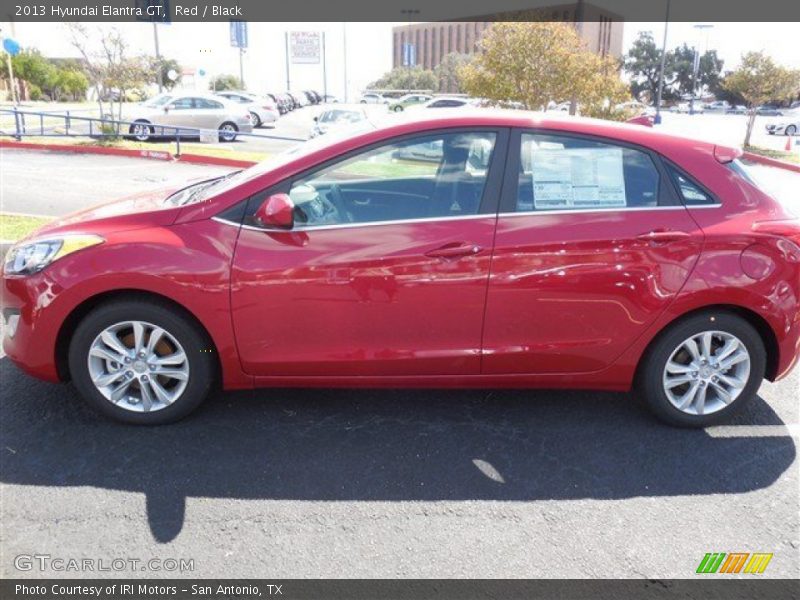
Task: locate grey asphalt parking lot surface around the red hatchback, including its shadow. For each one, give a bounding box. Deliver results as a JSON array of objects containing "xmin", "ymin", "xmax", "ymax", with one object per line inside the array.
[{"xmin": 0, "ymin": 150, "xmax": 800, "ymax": 578}]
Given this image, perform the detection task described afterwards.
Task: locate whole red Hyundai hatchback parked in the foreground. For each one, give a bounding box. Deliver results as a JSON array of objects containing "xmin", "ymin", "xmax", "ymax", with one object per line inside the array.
[{"xmin": 3, "ymin": 111, "xmax": 800, "ymax": 426}]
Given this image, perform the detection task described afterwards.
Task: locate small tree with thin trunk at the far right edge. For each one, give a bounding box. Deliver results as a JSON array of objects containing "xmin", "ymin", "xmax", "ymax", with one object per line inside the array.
[{"xmin": 723, "ymin": 52, "xmax": 800, "ymax": 146}]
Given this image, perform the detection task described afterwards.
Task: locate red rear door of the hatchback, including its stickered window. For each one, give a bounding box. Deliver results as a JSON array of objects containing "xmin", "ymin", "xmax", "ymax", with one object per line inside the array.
[{"xmin": 482, "ymin": 131, "xmax": 703, "ymax": 374}]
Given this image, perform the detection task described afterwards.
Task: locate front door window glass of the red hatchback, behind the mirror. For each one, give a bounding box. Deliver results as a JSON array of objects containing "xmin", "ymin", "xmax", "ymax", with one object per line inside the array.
[{"xmin": 289, "ymin": 132, "xmax": 496, "ymax": 226}]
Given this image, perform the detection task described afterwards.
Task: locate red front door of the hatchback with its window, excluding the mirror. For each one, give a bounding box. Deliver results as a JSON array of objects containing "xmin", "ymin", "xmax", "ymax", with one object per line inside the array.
[{"xmin": 232, "ymin": 130, "xmax": 507, "ymax": 377}]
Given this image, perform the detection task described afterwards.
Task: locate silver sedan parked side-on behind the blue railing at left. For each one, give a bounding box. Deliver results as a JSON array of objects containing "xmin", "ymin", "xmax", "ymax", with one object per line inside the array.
[{"xmin": 123, "ymin": 93, "xmax": 253, "ymax": 142}]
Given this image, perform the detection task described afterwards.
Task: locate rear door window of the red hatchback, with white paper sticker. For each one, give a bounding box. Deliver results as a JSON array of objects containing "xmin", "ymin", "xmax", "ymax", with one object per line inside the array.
[{"xmin": 516, "ymin": 134, "xmax": 661, "ymax": 212}]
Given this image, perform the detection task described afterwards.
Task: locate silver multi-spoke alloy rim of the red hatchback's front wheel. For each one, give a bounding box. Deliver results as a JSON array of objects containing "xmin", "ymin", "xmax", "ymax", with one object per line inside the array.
[{"xmin": 87, "ymin": 321, "xmax": 189, "ymax": 412}]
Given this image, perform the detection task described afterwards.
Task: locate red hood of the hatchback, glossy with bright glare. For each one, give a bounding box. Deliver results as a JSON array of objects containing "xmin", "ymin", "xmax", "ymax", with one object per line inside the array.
[{"xmin": 25, "ymin": 185, "xmax": 185, "ymax": 239}]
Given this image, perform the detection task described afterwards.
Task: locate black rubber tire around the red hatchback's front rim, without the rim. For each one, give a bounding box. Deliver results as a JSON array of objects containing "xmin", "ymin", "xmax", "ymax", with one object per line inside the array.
[{"xmin": 69, "ymin": 300, "xmax": 216, "ymax": 425}]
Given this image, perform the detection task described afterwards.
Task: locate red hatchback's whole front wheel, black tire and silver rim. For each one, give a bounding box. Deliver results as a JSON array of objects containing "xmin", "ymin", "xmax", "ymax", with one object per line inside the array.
[{"xmin": 69, "ymin": 301, "xmax": 215, "ymax": 425}]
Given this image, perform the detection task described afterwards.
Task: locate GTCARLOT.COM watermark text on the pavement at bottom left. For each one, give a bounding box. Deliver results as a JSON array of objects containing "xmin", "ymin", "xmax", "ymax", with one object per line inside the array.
[{"xmin": 14, "ymin": 554, "xmax": 194, "ymax": 573}]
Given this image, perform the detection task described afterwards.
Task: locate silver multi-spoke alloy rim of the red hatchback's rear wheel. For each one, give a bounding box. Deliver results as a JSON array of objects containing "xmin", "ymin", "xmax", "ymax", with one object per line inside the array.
[{"xmin": 663, "ymin": 331, "xmax": 751, "ymax": 415}]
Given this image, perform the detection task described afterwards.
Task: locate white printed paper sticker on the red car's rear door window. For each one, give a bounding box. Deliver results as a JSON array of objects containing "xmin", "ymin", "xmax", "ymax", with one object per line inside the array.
[{"xmin": 531, "ymin": 147, "xmax": 626, "ymax": 210}]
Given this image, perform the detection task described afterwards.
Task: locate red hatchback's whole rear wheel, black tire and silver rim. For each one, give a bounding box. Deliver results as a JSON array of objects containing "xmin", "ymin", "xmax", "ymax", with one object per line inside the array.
[{"xmin": 637, "ymin": 311, "xmax": 766, "ymax": 427}]
